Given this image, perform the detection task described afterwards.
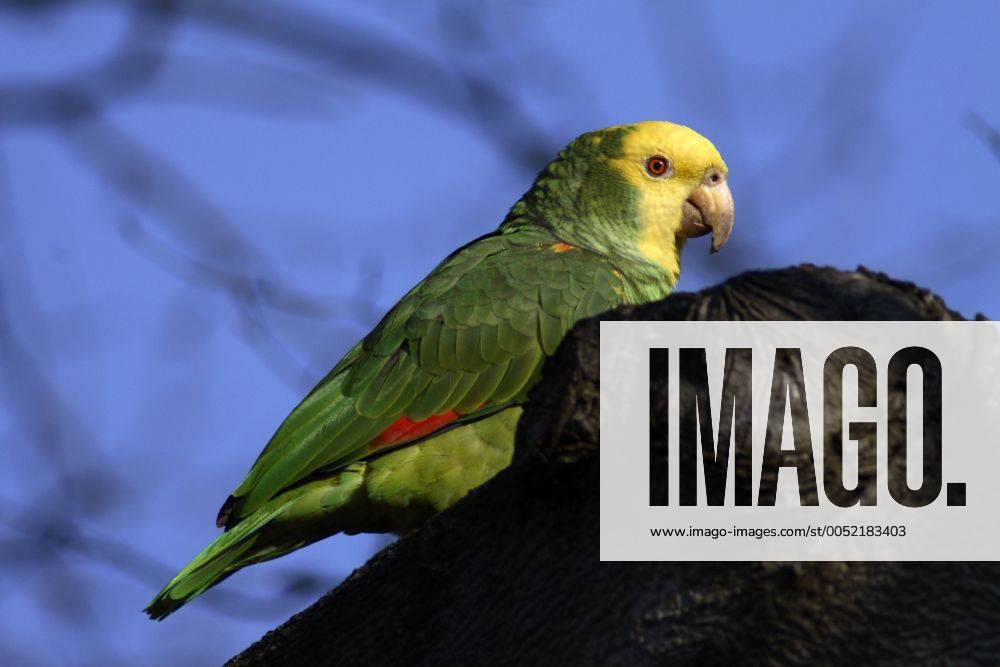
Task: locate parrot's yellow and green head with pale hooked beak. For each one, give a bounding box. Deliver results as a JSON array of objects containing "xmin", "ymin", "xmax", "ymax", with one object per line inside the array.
[{"xmin": 519, "ymin": 121, "xmax": 734, "ymax": 284}]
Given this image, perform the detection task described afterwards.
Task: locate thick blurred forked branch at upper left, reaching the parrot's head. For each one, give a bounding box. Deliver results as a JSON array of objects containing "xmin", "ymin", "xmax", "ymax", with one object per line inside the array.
[{"xmin": 0, "ymin": 1, "xmax": 572, "ymax": 389}]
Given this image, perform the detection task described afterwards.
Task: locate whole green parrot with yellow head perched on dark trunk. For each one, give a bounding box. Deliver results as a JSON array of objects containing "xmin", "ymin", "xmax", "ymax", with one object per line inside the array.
[{"xmin": 145, "ymin": 121, "xmax": 734, "ymax": 620}]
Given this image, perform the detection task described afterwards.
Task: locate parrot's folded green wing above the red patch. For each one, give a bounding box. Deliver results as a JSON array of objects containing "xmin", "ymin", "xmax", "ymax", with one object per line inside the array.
[{"xmin": 219, "ymin": 229, "xmax": 622, "ymax": 526}]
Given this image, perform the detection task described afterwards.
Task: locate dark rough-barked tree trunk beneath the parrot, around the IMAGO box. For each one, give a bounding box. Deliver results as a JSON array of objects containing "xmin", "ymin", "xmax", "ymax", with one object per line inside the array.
[{"xmin": 231, "ymin": 266, "xmax": 1000, "ymax": 665}]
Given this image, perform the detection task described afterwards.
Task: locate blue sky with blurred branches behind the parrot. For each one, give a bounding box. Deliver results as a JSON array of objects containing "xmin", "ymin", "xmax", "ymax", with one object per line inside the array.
[{"xmin": 0, "ymin": 0, "xmax": 1000, "ymax": 665}]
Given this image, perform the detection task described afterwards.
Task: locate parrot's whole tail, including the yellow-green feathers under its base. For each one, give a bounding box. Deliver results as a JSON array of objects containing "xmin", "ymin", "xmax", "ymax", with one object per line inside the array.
[{"xmin": 145, "ymin": 471, "xmax": 362, "ymax": 621}]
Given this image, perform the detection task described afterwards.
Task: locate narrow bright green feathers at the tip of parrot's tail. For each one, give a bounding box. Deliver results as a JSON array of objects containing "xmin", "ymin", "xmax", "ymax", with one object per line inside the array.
[{"xmin": 145, "ymin": 500, "xmax": 295, "ymax": 621}]
